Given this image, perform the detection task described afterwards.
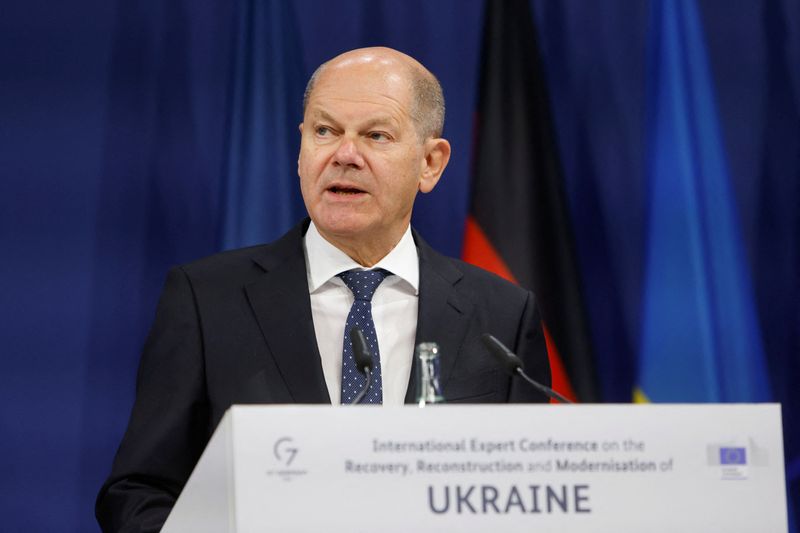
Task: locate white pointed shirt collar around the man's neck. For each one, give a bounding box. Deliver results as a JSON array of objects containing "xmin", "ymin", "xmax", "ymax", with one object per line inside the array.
[{"xmin": 303, "ymin": 221, "xmax": 419, "ymax": 295}]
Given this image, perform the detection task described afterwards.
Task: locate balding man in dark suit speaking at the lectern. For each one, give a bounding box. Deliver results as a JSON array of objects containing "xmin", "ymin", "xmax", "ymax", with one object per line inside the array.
[{"xmin": 96, "ymin": 48, "xmax": 550, "ymax": 532}]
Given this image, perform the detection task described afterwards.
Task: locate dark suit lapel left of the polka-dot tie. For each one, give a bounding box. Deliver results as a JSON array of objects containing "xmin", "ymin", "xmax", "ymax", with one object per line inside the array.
[{"xmin": 245, "ymin": 221, "xmax": 331, "ymax": 403}]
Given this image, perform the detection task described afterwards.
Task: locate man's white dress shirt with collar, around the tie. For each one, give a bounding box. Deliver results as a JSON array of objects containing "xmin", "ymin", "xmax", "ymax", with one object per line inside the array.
[{"xmin": 303, "ymin": 222, "xmax": 419, "ymax": 405}]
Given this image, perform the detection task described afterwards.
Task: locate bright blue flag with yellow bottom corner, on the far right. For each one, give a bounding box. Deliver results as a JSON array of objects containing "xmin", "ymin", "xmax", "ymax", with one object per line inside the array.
[{"xmin": 634, "ymin": 0, "xmax": 771, "ymax": 402}]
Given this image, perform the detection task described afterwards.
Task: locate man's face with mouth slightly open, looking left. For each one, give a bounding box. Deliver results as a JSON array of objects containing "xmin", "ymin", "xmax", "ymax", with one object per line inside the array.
[{"xmin": 298, "ymin": 61, "xmax": 438, "ymax": 250}]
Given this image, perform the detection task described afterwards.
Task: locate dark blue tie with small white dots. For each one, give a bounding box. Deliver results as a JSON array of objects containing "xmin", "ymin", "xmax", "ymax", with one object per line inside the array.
[{"xmin": 339, "ymin": 269, "xmax": 389, "ymax": 404}]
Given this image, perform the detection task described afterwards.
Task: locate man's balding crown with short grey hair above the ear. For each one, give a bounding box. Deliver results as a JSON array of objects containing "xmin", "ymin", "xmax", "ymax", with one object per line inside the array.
[{"xmin": 303, "ymin": 47, "xmax": 444, "ymax": 140}]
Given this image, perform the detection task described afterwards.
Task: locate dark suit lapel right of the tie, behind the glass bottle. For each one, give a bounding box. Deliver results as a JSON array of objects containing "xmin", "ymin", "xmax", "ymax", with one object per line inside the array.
[{"xmin": 405, "ymin": 232, "xmax": 473, "ymax": 403}]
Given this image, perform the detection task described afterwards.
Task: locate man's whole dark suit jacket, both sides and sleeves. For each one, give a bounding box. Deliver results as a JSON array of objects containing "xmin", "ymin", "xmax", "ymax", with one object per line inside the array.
[{"xmin": 96, "ymin": 220, "xmax": 550, "ymax": 532}]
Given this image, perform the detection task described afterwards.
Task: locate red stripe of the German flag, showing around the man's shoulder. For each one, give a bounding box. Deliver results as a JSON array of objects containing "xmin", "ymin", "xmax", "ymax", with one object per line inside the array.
[{"xmin": 462, "ymin": 216, "xmax": 576, "ymax": 403}]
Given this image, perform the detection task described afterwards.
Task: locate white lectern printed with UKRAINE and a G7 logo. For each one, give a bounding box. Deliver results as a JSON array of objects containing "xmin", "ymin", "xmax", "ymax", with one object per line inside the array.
[{"xmin": 163, "ymin": 404, "xmax": 787, "ymax": 533}]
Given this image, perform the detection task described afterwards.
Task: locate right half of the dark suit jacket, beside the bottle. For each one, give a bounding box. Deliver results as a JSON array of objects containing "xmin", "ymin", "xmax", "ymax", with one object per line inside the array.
[{"xmin": 407, "ymin": 233, "xmax": 550, "ymax": 403}]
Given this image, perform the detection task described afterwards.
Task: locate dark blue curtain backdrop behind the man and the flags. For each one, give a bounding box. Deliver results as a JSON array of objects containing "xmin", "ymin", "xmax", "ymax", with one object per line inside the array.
[{"xmin": 0, "ymin": 0, "xmax": 800, "ymax": 532}]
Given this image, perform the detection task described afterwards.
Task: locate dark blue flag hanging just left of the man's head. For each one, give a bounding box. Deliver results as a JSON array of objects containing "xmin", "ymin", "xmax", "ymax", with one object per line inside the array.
[{"xmin": 220, "ymin": 0, "xmax": 306, "ymax": 249}]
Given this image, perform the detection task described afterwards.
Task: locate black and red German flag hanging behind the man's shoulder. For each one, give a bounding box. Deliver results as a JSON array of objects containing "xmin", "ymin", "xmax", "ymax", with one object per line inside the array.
[{"xmin": 463, "ymin": 0, "xmax": 599, "ymax": 402}]
